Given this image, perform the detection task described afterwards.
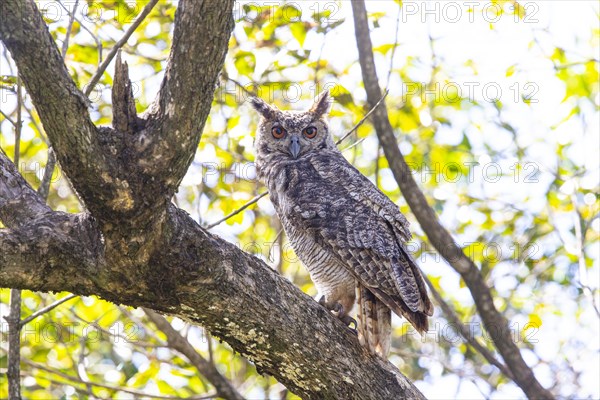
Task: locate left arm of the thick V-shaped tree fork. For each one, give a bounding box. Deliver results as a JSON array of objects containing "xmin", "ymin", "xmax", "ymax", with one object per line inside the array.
[{"xmin": 0, "ymin": 0, "xmax": 119, "ymax": 216}]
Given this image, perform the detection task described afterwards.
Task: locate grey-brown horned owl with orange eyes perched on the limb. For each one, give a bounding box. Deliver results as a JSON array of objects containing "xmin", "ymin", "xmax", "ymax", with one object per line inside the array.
[{"xmin": 250, "ymin": 92, "xmax": 433, "ymax": 357}]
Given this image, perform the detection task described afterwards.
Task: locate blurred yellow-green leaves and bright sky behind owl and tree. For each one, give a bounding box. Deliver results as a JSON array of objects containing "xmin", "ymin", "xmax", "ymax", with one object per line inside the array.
[{"xmin": 0, "ymin": 0, "xmax": 600, "ymax": 399}]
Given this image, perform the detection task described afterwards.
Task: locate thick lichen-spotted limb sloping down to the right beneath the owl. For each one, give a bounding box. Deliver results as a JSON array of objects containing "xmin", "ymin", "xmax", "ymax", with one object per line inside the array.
[{"xmin": 0, "ymin": 137, "xmax": 423, "ymax": 399}]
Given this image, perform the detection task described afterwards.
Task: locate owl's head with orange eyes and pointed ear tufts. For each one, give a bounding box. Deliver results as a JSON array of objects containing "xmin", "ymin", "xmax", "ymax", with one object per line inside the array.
[{"xmin": 250, "ymin": 91, "xmax": 335, "ymax": 159}]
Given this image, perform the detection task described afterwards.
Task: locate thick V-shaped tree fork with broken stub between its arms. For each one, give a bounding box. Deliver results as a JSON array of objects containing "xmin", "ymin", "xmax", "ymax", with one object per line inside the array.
[{"xmin": 0, "ymin": 0, "xmax": 233, "ymax": 225}]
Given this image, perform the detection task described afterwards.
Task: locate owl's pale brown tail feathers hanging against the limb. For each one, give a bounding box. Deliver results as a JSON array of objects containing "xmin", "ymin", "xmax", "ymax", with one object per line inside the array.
[{"xmin": 358, "ymin": 285, "xmax": 392, "ymax": 358}]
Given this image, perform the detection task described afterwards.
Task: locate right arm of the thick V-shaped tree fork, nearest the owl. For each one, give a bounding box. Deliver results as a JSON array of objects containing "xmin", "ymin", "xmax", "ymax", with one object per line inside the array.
[{"xmin": 140, "ymin": 0, "xmax": 234, "ymax": 199}]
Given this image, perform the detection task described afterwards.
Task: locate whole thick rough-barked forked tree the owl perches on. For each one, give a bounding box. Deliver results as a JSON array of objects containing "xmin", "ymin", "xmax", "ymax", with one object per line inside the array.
[{"xmin": 0, "ymin": 0, "xmax": 423, "ymax": 399}]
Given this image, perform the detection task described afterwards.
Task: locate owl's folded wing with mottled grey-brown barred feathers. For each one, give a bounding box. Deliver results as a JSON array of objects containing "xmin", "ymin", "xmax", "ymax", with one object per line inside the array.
[{"xmin": 286, "ymin": 153, "xmax": 432, "ymax": 322}]
